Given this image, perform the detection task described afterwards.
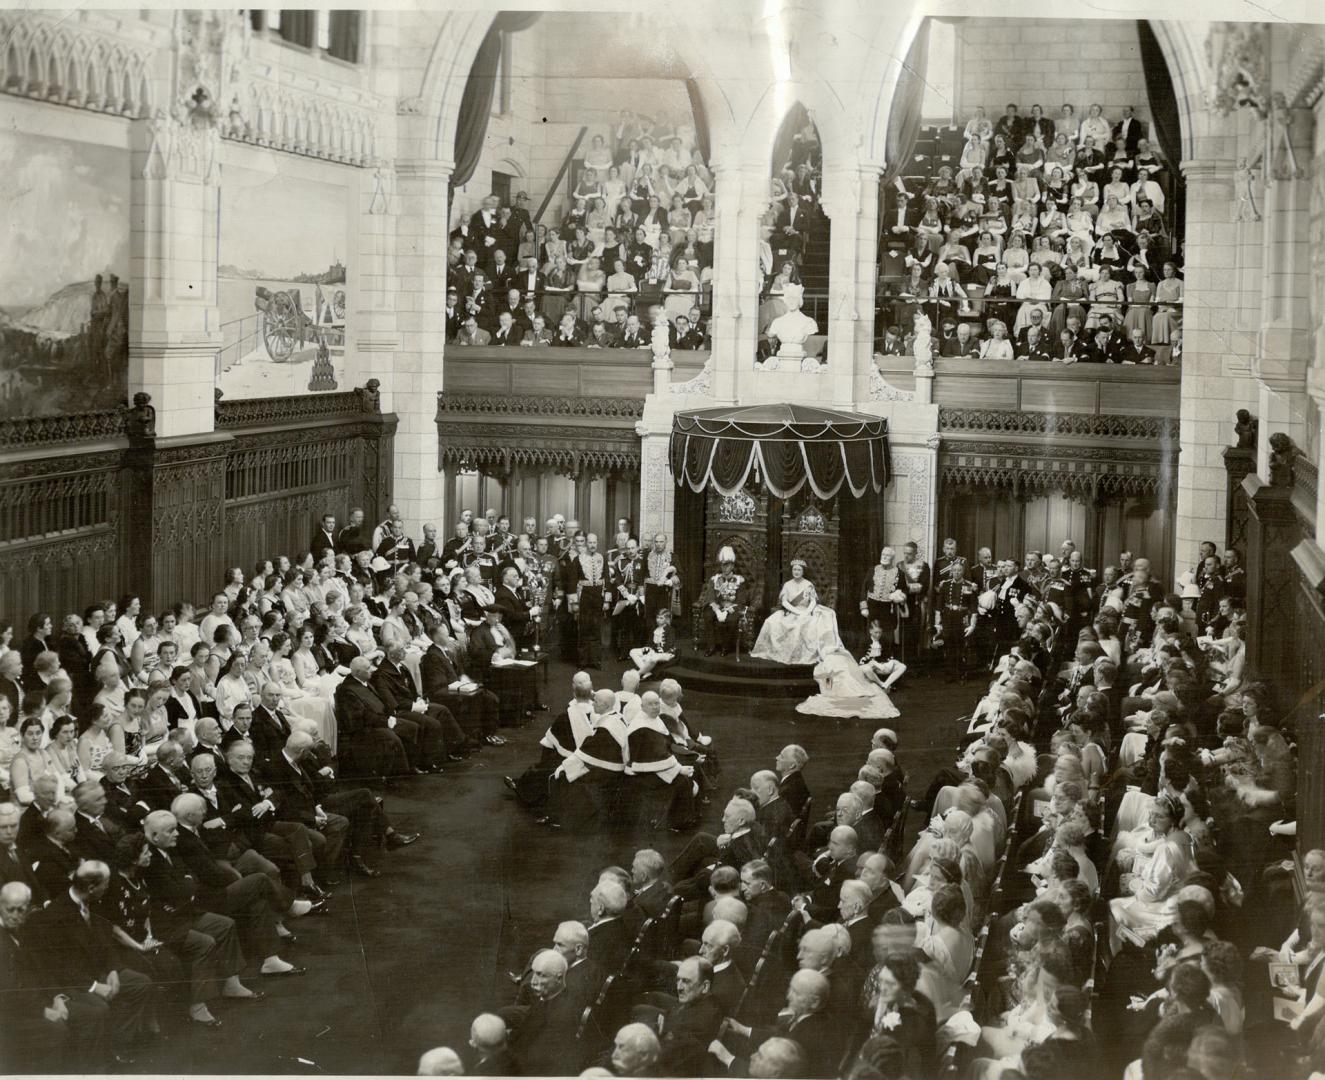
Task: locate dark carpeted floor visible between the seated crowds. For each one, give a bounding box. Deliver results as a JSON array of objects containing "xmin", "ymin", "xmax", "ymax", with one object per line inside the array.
[{"xmin": 119, "ymin": 664, "xmax": 978, "ymax": 1073}]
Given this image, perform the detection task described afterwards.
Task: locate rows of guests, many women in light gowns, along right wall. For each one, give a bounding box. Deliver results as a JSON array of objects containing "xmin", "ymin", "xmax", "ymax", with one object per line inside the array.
[{"xmin": 906, "ymin": 542, "xmax": 1298, "ymax": 1080}]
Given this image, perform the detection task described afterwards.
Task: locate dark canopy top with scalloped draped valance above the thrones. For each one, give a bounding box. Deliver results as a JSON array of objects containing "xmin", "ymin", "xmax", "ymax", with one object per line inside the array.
[{"xmin": 670, "ymin": 404, "xmax": 888, "ymax": 500}]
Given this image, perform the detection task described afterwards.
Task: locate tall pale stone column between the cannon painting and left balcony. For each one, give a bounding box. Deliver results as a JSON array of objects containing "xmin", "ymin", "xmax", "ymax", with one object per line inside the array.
[{"xmin": 389, "ymin": 160, "xmax": 452, "ymax": 534}]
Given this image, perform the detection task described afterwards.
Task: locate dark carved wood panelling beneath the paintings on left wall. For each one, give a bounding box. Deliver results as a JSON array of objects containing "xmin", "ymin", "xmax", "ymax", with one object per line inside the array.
[{"xmin": 0, "ymin": 382, "xmax": 396, "ymax": 624}]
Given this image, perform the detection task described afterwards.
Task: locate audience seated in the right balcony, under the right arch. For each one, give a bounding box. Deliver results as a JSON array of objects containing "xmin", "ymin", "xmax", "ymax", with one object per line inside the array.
[{"xmin": 881, "ymin": 105, "xmax": 1182, "ymax": 356}]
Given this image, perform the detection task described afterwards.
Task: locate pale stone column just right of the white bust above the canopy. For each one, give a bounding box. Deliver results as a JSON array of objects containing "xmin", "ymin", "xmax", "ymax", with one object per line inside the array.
[{"xmin": 823, "ymin": 166, "xmax": 880, "ymax": 408}]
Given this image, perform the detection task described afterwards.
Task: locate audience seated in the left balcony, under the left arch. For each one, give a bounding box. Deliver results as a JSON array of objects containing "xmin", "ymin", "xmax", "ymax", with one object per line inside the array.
[{"xmin": 447, "ymin": 110, "xmax": 717, "ymax": 349}]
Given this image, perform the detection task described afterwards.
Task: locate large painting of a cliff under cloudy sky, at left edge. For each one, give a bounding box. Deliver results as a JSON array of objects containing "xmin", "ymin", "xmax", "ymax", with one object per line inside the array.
[{"xmin": 0, "ymin": 131, "xmax": 129, "ymax": 417}]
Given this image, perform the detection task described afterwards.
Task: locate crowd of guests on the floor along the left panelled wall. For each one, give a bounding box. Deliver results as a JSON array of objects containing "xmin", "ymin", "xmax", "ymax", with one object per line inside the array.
[{"xmin": 0, "ymin": 508, "xmax": 670, "ymax": 1072}]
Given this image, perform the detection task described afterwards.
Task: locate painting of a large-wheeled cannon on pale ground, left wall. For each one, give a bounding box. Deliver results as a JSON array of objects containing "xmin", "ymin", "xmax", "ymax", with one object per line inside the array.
[{"xmin": 216, "ymin": 164, "xmax": 348, "ymax": 398}]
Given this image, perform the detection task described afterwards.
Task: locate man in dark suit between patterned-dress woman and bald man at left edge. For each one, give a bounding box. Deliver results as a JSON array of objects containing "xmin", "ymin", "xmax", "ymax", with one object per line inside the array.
[{"xmin": 25, "ymin": 860, "xmax": 152, "ymax": 1065}]
